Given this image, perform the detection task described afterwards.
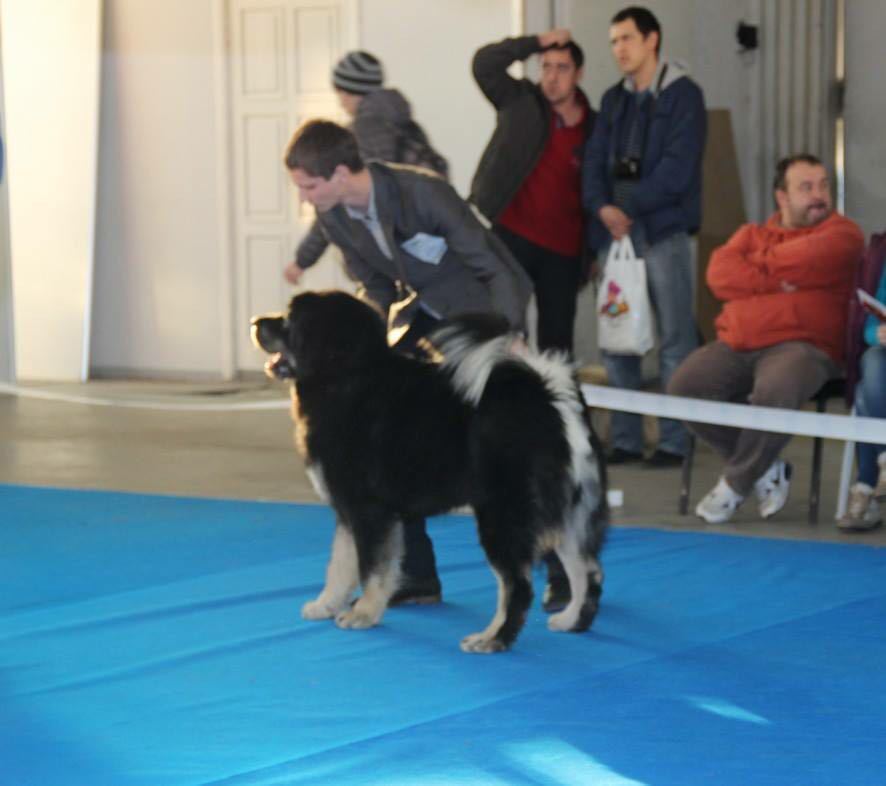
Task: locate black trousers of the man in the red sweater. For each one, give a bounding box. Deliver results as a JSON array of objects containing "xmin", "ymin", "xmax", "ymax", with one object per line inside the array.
[{"xmin": 493, "ymin": 224, "xmax": 581, "ymax": 357}]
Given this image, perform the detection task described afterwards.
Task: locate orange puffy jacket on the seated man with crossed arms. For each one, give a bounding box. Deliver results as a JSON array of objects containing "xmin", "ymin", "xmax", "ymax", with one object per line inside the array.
[{"xmin": 707, "ymin": 213, "xmax": 864, "ymax": 365}]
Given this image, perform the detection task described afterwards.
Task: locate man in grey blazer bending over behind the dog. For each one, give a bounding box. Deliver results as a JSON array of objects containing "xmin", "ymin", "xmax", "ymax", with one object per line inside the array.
[{"xmin": 285, "ymin": 120, "xmax": 532, "ymax": 604}]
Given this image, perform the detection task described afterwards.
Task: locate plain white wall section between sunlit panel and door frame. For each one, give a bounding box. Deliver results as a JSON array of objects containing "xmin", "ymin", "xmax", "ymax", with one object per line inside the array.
[{"xmin": 92, "ymin": 0, "xmax": 229, "ymax": 377}]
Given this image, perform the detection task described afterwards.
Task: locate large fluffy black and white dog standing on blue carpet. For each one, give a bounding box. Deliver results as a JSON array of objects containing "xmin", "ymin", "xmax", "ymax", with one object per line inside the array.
[{"xmin": 252, "ymin": 291, "xmax": 608, "ymax": 652}]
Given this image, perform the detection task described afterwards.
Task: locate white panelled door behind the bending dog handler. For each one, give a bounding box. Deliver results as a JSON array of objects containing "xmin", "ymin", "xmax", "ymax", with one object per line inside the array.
[{"xmin": 228, "ymin": 0, "xmax": 357, "ymax": 371}]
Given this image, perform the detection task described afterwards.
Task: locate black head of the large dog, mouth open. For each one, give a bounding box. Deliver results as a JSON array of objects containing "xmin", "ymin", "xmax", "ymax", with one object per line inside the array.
[{"xmin": 252, "ymin": 290, "xmax": 388, "ymax": 379}]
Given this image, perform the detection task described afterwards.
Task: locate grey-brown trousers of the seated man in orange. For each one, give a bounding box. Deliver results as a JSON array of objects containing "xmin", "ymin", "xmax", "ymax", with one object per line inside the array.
[{"xmin": 668, "ymin": 341, "xmax": 840, "ymax": 496}]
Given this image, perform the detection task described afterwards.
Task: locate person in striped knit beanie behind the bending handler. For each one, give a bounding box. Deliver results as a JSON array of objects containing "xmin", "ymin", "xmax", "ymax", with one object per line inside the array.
[{"xmin": 283, "ymin": 50, "xmax": 448, "ymax": 284}]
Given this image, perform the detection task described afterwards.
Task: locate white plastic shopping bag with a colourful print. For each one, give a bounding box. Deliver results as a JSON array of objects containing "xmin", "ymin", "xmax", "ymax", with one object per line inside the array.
[{"xmin": 597, "ymin": 235, "xmax": 654, "ymax": 355}]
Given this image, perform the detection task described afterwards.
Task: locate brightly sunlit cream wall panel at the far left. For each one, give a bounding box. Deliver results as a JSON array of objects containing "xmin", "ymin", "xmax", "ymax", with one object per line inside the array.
[{"xmin": 0, "ymin": 0, "xmax": 101, "ymax": 380}]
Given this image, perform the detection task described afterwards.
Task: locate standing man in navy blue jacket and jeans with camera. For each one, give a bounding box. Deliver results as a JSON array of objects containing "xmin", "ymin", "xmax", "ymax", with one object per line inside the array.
[{"xmin": 582, "ymin": 6, "xmax": 707, "ymax": 467}]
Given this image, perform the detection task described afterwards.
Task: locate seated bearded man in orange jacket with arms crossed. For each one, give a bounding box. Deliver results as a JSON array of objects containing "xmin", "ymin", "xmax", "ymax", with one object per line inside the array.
[{"xmin": 668, "ymin": 154, "xmax": 864, "ymax": 524}]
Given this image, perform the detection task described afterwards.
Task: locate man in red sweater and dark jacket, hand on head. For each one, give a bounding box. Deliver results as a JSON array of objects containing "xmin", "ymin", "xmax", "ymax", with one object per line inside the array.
[{"xmin": 469, "ymin": 29, "xmax": 596, "ymax": 353}]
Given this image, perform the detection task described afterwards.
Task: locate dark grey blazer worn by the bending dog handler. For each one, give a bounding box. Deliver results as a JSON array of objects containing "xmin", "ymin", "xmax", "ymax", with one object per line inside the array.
[{"xmin": 318, "ymin": 162, "xmax": 532, "ymax": 330}]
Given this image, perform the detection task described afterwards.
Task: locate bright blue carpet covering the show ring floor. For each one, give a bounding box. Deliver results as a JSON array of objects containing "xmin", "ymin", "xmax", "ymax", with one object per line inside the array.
[{"xmin": 0, "ymin": 486, "xmax": 886, "ymax": 786}]
